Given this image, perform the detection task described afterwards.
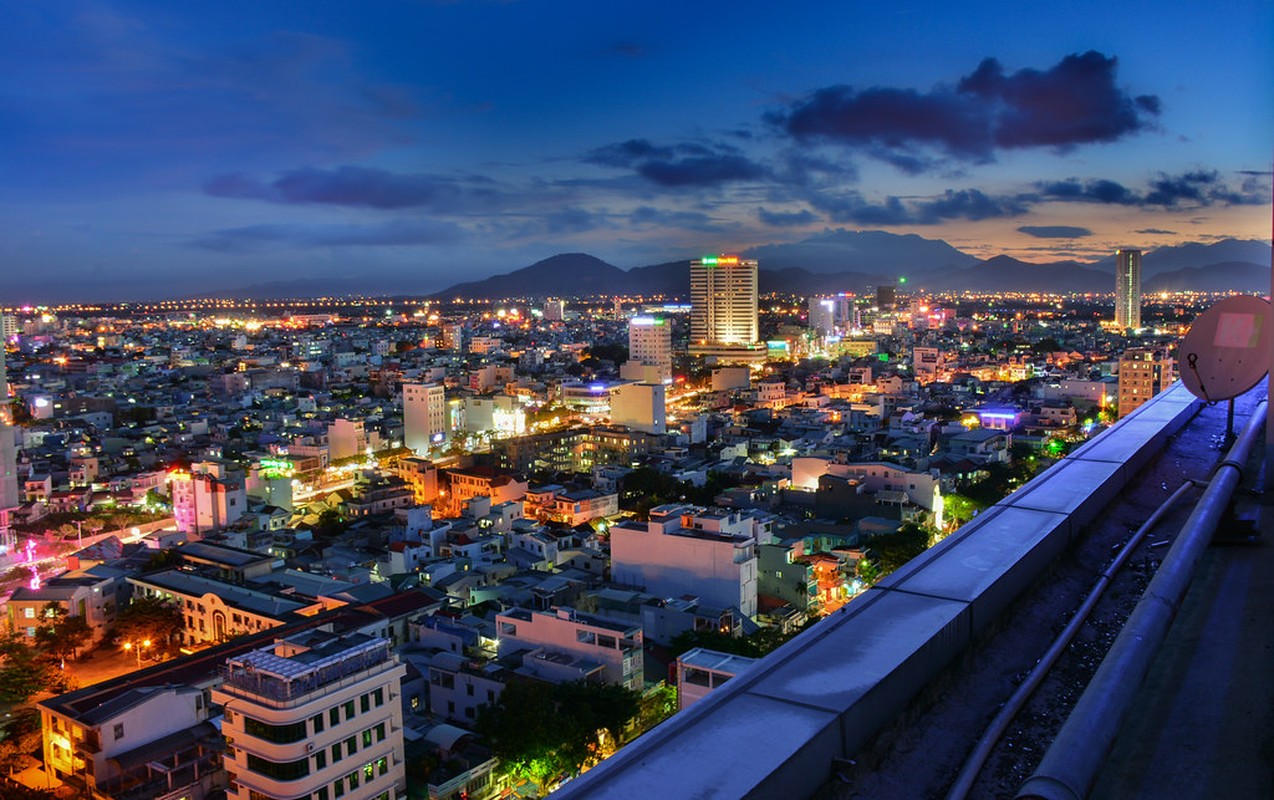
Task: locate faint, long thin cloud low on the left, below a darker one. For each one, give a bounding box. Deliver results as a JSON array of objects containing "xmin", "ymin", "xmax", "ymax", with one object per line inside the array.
[{"xmin": 191, "ymin": 220, "xmax": 464, "ymax": 252}]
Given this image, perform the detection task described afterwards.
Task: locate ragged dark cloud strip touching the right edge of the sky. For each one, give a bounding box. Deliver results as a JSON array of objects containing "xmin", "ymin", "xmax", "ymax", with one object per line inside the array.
[{"xmin": 1036, "ymin": 169, "xmax": 1269, "ymax": 208}]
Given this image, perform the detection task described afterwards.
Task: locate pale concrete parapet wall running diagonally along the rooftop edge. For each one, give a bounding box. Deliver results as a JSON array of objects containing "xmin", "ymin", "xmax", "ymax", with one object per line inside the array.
[{"xmin": 553, "ymin": 382, "xmax": 1199, "ymax": 800}]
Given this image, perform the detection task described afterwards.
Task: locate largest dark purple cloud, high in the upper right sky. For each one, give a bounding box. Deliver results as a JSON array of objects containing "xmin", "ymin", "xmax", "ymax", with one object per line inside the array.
[{"xmin": 767, "ymin": 51, "xmax": 1159, "ymax": 166}]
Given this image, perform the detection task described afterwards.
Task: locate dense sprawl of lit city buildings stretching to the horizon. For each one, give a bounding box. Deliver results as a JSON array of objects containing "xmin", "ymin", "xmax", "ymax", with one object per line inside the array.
[{"xmin": 0, "ymin": 262, "xmax": 1253, "ymax": 800}]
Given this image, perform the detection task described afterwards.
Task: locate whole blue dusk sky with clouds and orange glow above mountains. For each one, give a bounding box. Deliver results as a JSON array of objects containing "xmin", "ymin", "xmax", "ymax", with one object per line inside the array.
[{"xmin": 0, "ymin": 0, "xmax": 1274, "ymax": 302}]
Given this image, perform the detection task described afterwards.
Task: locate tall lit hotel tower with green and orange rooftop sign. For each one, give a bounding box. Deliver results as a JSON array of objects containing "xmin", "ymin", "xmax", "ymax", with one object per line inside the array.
[{"xmin": 691, "ymin": 255, "xmax": 766, "ymax": 362}]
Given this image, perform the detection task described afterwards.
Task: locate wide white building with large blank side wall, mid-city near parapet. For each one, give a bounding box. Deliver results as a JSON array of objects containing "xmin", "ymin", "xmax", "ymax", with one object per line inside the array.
[{"xmin": 610, "ymin": 504, "xmax": 754, "ymax": 617}]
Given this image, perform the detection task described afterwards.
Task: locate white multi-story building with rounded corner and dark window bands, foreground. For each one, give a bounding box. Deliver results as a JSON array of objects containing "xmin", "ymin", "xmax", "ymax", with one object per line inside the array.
[{"xmin": 213, "ymin": 632, "xmax": 406, "ymax": 800}]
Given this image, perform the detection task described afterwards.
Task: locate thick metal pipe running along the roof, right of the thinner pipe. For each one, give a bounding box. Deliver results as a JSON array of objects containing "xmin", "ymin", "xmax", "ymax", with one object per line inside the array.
[{"xmin": 1017, "ymin": 400, "xmax": 1268, "ymax": 800}]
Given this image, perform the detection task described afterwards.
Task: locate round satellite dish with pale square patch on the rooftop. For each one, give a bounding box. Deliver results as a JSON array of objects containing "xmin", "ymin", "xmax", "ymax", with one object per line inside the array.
[{"xmin": 1177, "ymin": 294, "xmax": 1274, "ymax": 403}]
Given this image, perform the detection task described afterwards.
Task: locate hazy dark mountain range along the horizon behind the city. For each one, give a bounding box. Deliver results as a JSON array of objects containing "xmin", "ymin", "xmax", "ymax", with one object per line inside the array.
[{"xmin": 433, "ymin": 231, "xmax": 1270, "ymax": 299}]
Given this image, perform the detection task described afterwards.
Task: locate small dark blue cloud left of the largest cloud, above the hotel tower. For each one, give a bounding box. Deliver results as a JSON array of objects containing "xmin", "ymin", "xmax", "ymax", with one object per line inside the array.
[{"xmin": 585, "ymin": 139, "xmax": 766, "ymax": 189}]
